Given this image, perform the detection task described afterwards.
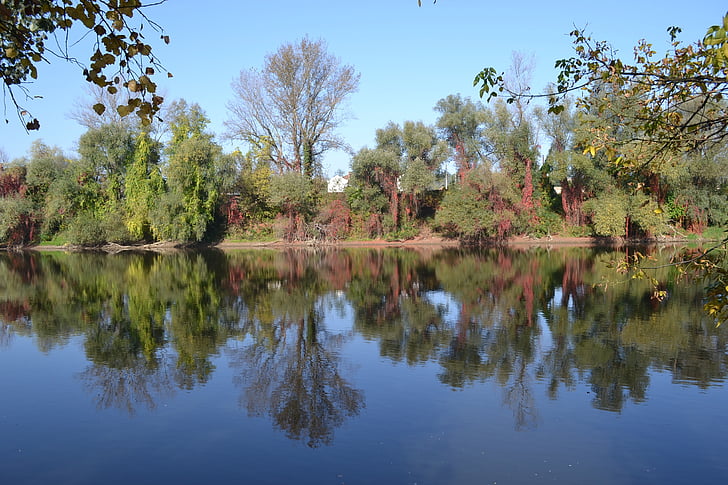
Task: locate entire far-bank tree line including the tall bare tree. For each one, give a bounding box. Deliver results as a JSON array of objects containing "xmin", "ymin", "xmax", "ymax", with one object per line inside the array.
[{"xmin": 0, "ymin": 38, "xmax": 728, "ymax": 246}]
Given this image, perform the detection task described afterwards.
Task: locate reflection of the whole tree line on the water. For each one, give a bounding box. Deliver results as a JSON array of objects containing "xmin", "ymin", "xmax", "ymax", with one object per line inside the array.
[{"xmin": 0, "ymin": 248, "xmax": 728, "ymax": 434}]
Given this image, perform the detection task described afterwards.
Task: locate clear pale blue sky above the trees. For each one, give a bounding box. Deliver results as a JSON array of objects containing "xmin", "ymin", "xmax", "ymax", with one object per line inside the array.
[{"xmin": 0, "ymin": 0, "xmax": 728, "ymax": 175}]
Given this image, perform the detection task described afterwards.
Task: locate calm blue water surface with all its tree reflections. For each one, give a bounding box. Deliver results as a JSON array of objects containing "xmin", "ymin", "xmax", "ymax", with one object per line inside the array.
[{"xmin": 0, "ymin": 248, "xmax": 728, "ymax": 485}]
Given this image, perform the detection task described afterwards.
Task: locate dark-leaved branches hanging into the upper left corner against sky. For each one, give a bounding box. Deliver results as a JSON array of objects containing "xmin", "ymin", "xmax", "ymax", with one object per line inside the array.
[{"xmin": 0, "ymin": 0, "xmax": 171, "ymax": 130}]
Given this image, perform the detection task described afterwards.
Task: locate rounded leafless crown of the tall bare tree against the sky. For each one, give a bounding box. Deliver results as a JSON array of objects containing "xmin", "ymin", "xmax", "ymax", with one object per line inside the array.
[{"xmin": 225, "ymin": 38, "xmax": 359, "ymax": 177}]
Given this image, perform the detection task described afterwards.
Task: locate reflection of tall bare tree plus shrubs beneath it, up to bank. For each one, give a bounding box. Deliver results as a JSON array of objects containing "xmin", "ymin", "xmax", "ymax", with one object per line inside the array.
[{"xmin": 231, "ymin": 250, "xmax": 364, "ymax": 447}]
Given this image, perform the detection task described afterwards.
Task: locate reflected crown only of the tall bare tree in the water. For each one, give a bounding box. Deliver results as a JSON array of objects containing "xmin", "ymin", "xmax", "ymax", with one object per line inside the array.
[{"xmin": 231, "ymin": 309, "xmax": 364, "ymax": 447}]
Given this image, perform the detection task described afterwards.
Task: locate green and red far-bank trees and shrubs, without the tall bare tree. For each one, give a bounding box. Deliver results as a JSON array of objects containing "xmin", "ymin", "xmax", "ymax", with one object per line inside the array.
[{"xmin": 0, "ymin": 87, "xmax": 728, "ymax": 246}]
